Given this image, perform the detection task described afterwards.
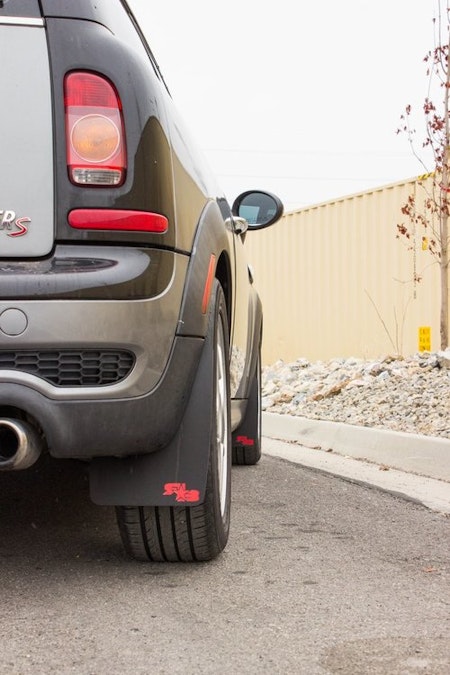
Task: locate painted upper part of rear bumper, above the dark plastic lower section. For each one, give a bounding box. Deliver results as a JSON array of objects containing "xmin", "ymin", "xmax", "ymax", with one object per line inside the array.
[{"xmin": 0, "ymin": 246, "xmax": 189, "ymax": 401}]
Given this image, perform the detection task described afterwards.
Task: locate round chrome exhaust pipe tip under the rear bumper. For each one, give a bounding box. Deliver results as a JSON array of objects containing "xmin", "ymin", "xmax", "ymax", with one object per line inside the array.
[{"xmin": 0, "ymin": 417, "xmax": 43, "ymax": 471}]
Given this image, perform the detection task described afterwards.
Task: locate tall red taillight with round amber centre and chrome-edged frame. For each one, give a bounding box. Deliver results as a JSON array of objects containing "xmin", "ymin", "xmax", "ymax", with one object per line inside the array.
[{"xmin": 64, "ymin": 72, "xmax": 126, "ymax": 186}]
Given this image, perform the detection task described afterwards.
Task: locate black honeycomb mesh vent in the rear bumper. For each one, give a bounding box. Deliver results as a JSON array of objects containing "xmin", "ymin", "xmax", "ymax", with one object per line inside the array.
[{"xmin": 0, "ymin": 349, "xmax": 135, "ymax": 387}]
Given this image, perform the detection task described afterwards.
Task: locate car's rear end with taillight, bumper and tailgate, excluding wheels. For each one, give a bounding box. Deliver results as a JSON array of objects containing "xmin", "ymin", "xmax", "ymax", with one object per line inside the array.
[{"xmin": 0, "ymin": 0, "xmax": 203, "ymax": 469}]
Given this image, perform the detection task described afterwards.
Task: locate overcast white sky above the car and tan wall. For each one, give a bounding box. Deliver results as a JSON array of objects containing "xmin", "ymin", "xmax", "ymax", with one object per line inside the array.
[{"xmin": 129, "ymin": 0, "xmax": 438, "ymax": 210}]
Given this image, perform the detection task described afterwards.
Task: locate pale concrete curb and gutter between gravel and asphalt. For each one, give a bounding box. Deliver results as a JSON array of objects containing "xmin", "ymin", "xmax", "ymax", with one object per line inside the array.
[{"xmin": 263, "ymin": 413, "xmax": 450, "ymax": 514}]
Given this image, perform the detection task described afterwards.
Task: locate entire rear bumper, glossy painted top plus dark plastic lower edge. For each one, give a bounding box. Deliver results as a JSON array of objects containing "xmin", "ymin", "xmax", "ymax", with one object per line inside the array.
[{"xmin": 0, "ymin": 246, "xmax": 204, "ymax": 459}]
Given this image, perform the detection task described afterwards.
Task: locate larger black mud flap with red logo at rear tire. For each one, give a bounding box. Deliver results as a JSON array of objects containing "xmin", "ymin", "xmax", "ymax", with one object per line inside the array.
[{"xmin": 90, "ymin": 335, "xmax": 215, "ymax": 506}]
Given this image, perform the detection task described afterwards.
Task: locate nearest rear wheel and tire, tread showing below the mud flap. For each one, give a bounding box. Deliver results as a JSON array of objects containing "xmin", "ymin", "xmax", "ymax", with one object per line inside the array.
[{"xmin": 116, "ymin": 282, "xmax": 231, "ymax": 562}]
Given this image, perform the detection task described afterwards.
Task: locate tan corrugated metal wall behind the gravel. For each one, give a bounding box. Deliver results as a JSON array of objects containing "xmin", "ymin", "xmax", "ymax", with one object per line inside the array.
[{"xmin": 246, "ymin": 174, "xmax": 440, "ymax": 364}]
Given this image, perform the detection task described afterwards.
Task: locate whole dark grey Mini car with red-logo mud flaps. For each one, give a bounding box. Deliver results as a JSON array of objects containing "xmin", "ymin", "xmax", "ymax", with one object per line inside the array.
[{"xmin": 0, "ymin": 0, "xmax": 282, "ymax": 561}]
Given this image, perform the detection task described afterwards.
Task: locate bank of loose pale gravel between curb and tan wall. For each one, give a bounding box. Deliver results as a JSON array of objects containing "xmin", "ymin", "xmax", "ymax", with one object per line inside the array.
[{"xmin": 262, "ymin": 350, "xmax": 450, "ymax": 439}]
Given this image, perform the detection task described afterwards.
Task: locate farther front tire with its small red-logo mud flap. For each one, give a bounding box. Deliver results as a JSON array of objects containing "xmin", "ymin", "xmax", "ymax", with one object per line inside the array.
[{"xmin": 232, "ymin": 346, "xmax": 262, "ymax": 466}]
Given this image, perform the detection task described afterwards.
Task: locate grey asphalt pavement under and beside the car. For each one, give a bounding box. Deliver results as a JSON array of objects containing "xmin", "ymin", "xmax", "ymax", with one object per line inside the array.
[{"xmin": 0, "ymin": 446, "xmax": 450, "ymax": 675}]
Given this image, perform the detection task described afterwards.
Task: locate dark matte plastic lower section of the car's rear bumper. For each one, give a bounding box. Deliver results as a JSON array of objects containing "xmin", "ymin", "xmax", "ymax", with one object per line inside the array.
[{"xmin": 0, "ymin": 337, "xmax": 204, "ymax": 459}]
